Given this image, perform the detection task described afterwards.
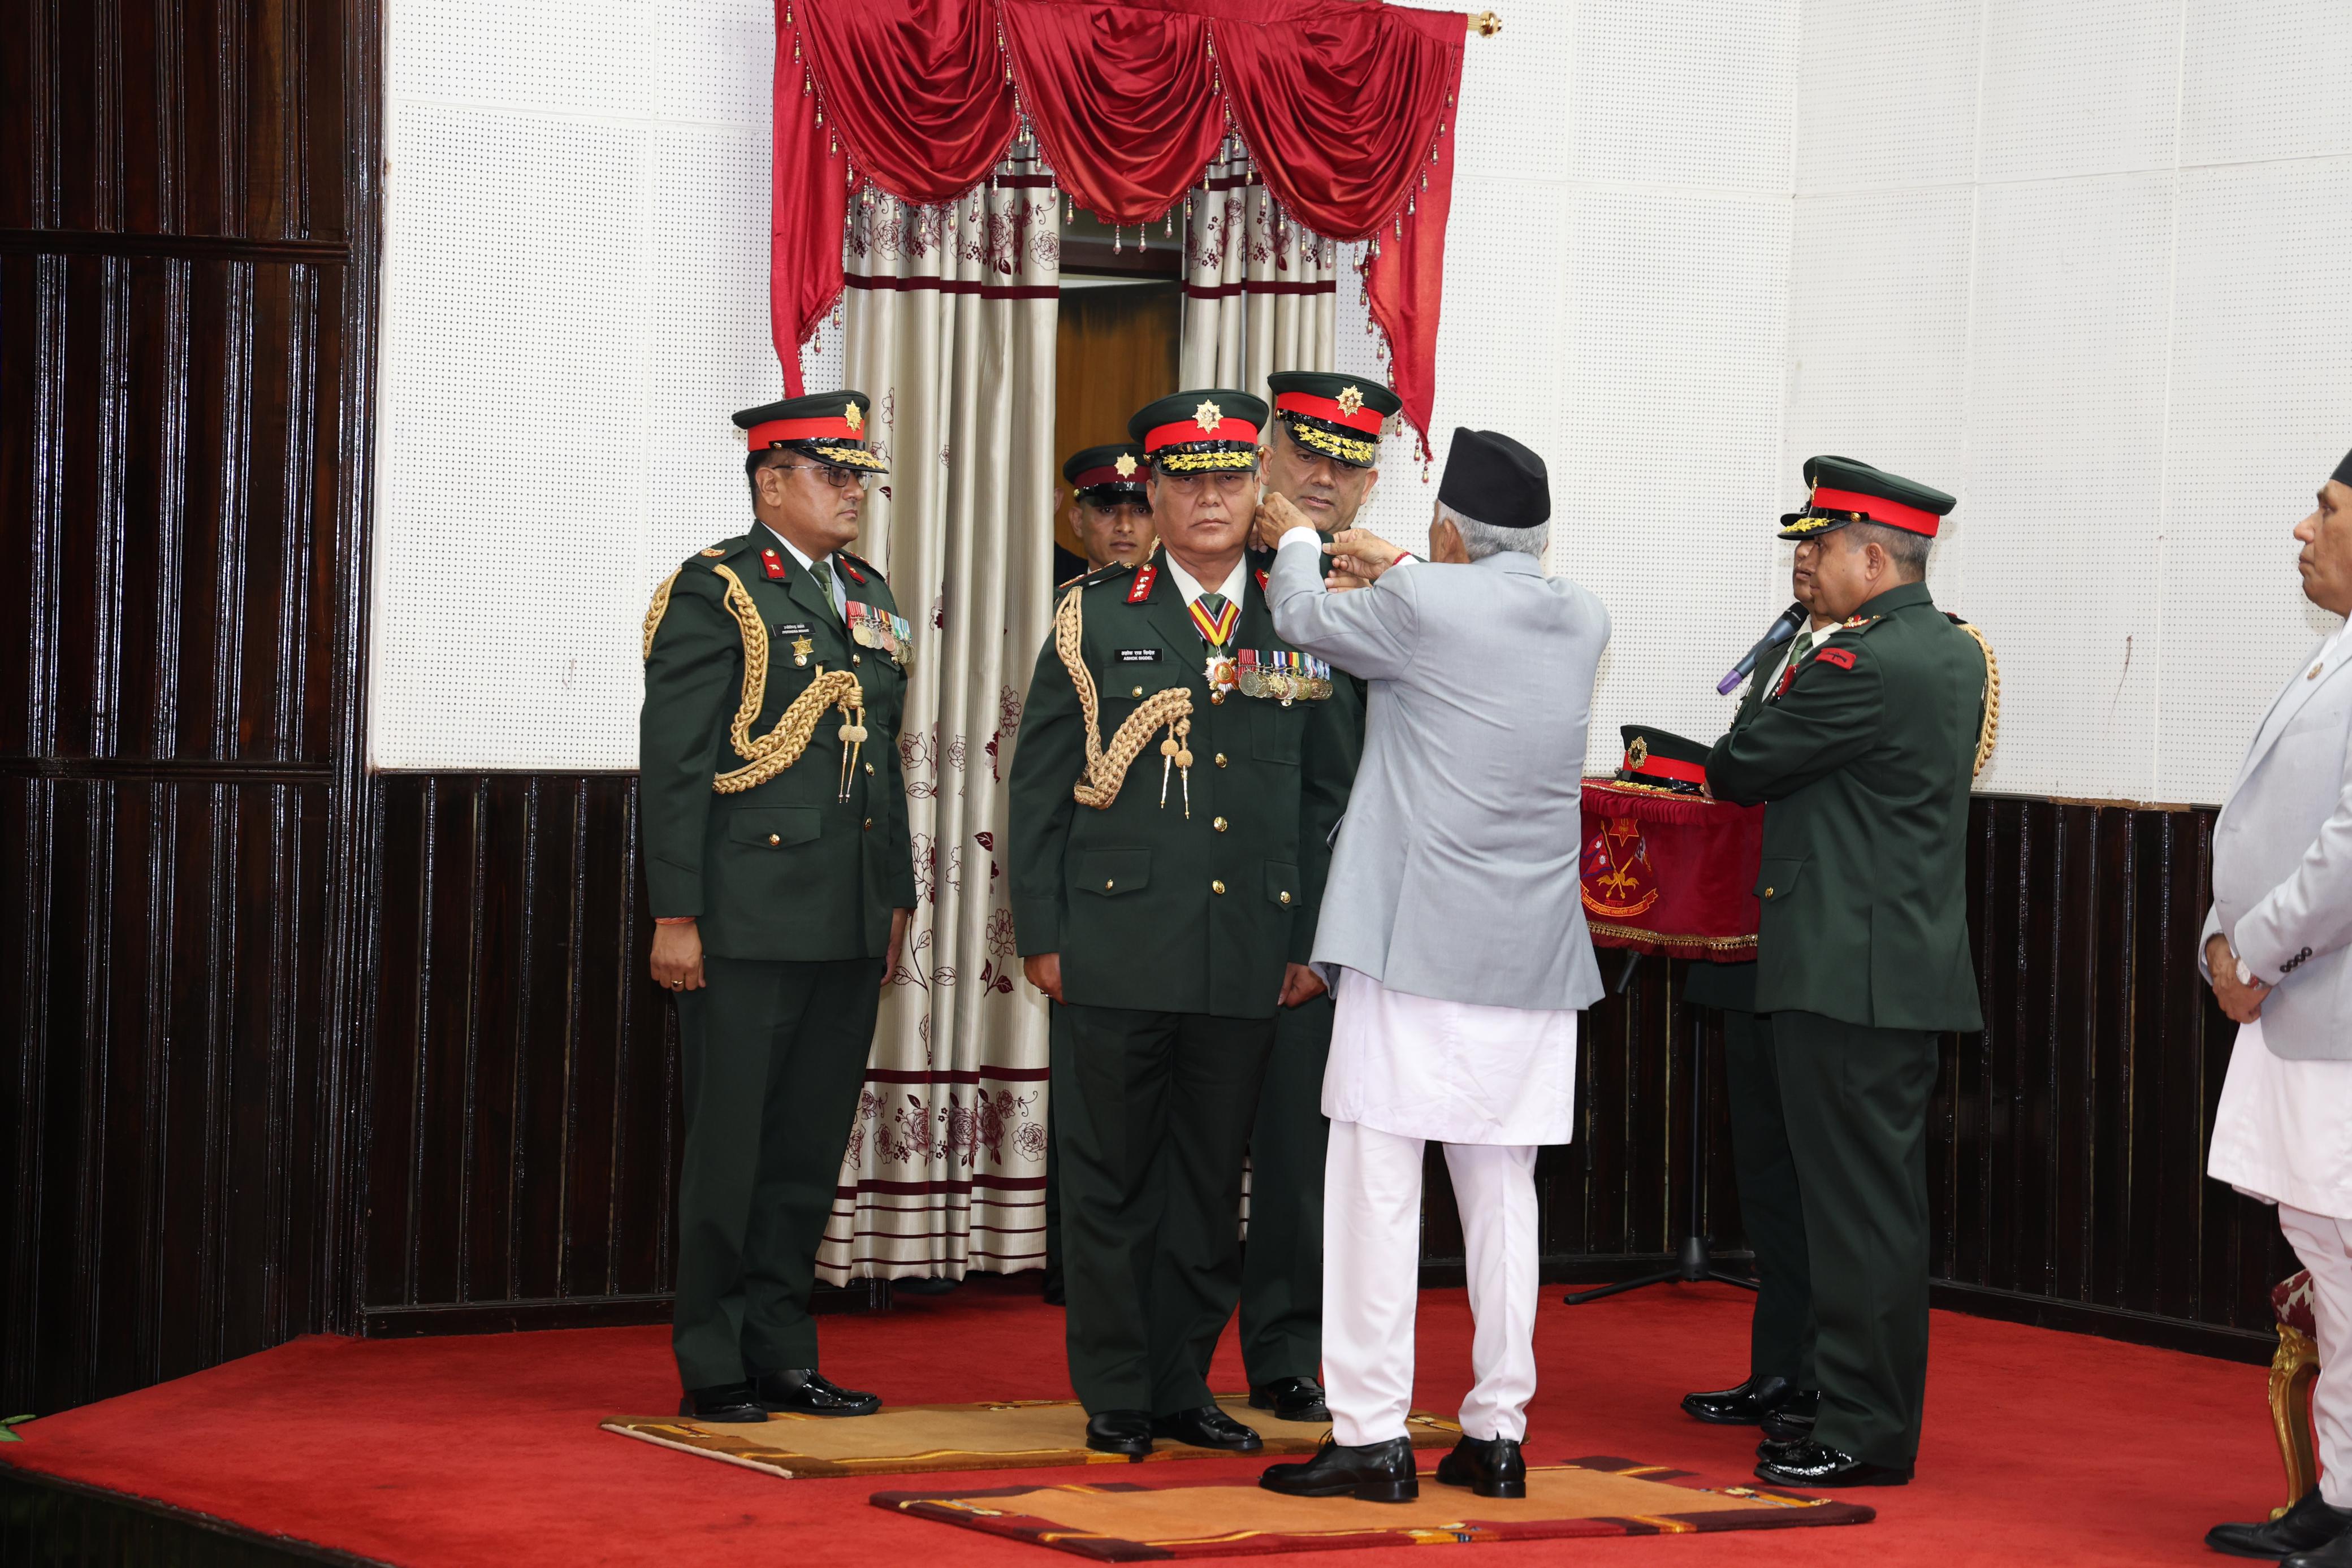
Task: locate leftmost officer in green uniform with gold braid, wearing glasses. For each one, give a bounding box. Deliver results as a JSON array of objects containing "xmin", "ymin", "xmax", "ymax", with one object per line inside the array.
[{"xmin": 637, "ymin": 393, "xmax": 915, "ymax": 1420}]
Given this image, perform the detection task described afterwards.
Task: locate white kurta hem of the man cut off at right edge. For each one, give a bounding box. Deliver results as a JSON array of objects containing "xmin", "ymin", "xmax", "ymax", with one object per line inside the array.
[{"xmin": 2206, "ymin": 1018, "xmax": 2352, "ymax": 1220}]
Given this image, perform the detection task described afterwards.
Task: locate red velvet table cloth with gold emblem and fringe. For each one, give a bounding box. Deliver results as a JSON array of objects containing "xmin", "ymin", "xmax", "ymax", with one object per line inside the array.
[{"xmin": 1581, "ymin": 778, "xmax": 1764, "ymax": 964}]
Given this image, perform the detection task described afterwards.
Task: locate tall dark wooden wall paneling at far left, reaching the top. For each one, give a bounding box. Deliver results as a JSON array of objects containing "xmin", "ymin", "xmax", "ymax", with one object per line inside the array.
[{"xmin": 0, "ymin": 0, "xmax": 381, "ymax": 1410}]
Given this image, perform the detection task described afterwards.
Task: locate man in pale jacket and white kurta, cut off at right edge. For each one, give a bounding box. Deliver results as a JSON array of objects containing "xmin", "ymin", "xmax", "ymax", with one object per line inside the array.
[{"xmin": 2201, "ymin": 456, "xmax": 2352, "ymax": 1568}]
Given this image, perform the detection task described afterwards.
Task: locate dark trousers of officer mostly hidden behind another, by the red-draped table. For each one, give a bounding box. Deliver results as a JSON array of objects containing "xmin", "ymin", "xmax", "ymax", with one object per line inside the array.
[{"xmin": 1722, "ymin": 1008, "xmax": 1818, "ymax": 1389}]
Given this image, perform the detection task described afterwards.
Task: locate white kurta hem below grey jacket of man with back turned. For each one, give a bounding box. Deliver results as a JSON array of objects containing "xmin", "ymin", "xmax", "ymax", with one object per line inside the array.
[{"xmin": 1322, "ymin": 968, "xmax": 1576, "ymax": 1145}]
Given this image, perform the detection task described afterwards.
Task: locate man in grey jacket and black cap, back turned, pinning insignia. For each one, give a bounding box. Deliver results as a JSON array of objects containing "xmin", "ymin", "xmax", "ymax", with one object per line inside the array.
[{"xmin": 1259, "ymin": 430, "xmax": 1609, "ymax": 1502}]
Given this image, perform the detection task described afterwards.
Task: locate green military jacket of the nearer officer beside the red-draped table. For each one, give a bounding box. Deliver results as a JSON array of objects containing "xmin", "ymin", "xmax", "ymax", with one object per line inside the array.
[{"xmin": 1707, "ymin": 583, "xmax": 1985, "ymax": 1030}]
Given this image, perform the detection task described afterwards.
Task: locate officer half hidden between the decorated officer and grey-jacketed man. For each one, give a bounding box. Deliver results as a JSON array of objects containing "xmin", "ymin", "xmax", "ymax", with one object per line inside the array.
[{"xmin": 1242, "ymin": 371, "xmax": 1404, "ymax": 1420}]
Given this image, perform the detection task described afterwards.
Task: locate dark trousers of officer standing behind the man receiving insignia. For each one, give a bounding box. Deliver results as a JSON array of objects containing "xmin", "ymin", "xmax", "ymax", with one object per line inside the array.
[{"xmin": 1242, "ymin": 992, "xmax": 1331, "ymax": 1385}]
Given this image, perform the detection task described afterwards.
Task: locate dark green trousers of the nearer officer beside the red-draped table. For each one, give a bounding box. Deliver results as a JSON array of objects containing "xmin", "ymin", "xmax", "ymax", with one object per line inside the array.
[{"xmin": 1771, "ymin": 1011, "xmax": 1936, "ymax": 1465}]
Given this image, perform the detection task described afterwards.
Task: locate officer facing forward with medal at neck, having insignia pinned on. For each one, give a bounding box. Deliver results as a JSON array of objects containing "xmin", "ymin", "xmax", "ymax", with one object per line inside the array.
[{"xmin": 1011, "ymin": 390, "xmax": 1362, "ymax": 1455}]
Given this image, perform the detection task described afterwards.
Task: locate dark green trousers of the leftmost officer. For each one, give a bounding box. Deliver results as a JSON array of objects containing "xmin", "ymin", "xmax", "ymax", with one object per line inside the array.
[{"xmin": 671, "ymin": 955, "xmax": 882, "ymax": 1389}]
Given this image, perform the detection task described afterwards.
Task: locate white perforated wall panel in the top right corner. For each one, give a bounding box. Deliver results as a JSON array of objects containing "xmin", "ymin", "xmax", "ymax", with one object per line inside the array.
[{"xmin": 2180, "ymin": 0, "xmax": 2352, "ymax": 164}]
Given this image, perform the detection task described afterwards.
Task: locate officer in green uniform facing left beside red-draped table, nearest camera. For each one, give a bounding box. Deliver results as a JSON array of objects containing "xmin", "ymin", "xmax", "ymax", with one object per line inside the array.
[{"xmin": 1707, "ymin": 458, "xmax": 1987, "ymax": 1488}]
